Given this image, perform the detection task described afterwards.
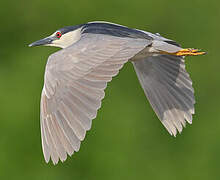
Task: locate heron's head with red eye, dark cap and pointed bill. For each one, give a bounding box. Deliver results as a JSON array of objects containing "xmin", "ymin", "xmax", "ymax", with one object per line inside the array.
[{"xmin": 29, "ymin": 26, "xmax": 82, "ymax": 48}]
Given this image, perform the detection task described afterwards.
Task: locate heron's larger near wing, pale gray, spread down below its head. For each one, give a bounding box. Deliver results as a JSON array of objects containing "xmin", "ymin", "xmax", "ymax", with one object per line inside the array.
[{"xmin": 41, "ymin": 34, "xmax": 150, "ymax": 164}]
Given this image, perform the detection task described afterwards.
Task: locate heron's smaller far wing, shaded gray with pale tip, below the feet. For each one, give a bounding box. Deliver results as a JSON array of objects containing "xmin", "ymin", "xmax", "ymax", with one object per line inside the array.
[{"xmin": 133, "ymin": 55, "xmax": 195, "ymax": 136}]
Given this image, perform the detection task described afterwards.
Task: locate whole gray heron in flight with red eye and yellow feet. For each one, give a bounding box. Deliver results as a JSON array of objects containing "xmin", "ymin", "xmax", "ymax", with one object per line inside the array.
[{"xmin": 29, "ymin": 21, "xmax": 205, "ymax": 164}]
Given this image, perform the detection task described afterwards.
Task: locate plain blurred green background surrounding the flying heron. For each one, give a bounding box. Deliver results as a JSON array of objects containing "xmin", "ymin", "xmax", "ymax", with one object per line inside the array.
[{"xmin": 0, "ymin": 0, "xmax": 220, "ymax": 180}]
